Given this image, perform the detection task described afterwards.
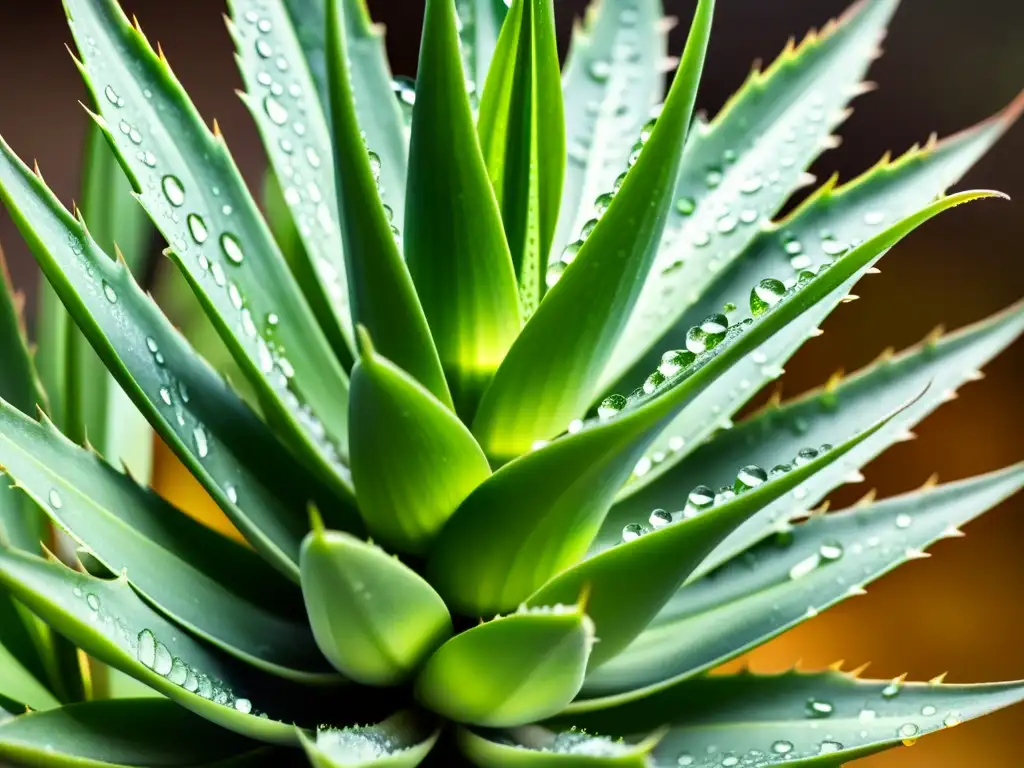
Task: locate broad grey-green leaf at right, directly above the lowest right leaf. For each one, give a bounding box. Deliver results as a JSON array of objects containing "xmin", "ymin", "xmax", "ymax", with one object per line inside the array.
[{"xmin": 584, "ymin": 465, "xmax": 1024, "ymax": 700}]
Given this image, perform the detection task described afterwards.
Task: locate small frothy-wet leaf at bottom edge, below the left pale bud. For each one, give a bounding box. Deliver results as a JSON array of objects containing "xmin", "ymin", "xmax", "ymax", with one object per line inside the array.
[{"xmin": 300, "ymin": 712, "xmax": 440, "ymax": 768}]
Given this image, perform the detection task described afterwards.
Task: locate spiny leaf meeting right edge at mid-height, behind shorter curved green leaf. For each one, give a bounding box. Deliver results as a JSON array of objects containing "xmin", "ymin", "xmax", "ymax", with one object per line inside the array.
[{"xmin": 601, "ymin": 296, "xmax": 1024, "ymax": 575}]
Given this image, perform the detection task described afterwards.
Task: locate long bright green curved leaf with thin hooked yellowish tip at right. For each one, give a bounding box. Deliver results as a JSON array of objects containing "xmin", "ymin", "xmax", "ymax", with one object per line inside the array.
[{"xmin": 427, "ymin": 191, "xmax": 994, "ymax": 615}]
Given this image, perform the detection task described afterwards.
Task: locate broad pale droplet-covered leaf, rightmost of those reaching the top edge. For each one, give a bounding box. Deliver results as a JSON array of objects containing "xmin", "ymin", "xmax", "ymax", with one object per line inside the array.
[{"xmin": 601, "ymin": 0, "xmax": 901, "ymax": 389}]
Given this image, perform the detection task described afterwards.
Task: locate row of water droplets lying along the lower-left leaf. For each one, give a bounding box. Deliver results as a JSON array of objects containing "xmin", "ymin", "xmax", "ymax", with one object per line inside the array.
[{"xmin": 69, "ymin": 589, "xmax": 256, "ymax": 718}]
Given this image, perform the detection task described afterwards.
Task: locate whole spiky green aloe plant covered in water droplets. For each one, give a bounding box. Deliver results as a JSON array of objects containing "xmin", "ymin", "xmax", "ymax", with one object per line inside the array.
[{"xmin": 0, "ymin": 0, "xmax": 1024, "ymax": 768}]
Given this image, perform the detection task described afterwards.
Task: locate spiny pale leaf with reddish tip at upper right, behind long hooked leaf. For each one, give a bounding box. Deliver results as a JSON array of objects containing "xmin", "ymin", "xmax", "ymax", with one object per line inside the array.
[{"xmin": 625, "ymin": 90, "xmax": 1024, "ymax": 494}]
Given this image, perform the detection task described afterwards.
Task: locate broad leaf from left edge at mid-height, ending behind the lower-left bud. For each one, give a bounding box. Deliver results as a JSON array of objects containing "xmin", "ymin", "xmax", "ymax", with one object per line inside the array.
[{"xmin": 0, "ymin": 400, "xmax": 336, "ymax": 683}]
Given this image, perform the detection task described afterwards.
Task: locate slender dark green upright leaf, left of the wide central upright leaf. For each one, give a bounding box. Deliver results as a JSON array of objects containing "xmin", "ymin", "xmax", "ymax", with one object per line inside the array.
[{"xmin": 328, "ymin": 0, "xmax": 452, "ymax": 404}]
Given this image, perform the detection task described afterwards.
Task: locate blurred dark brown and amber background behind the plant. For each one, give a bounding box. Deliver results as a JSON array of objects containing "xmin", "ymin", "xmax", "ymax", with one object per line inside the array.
[{"xmin": 0, "ymin": 0, "xmax": 1024, "ymax": 768}]
